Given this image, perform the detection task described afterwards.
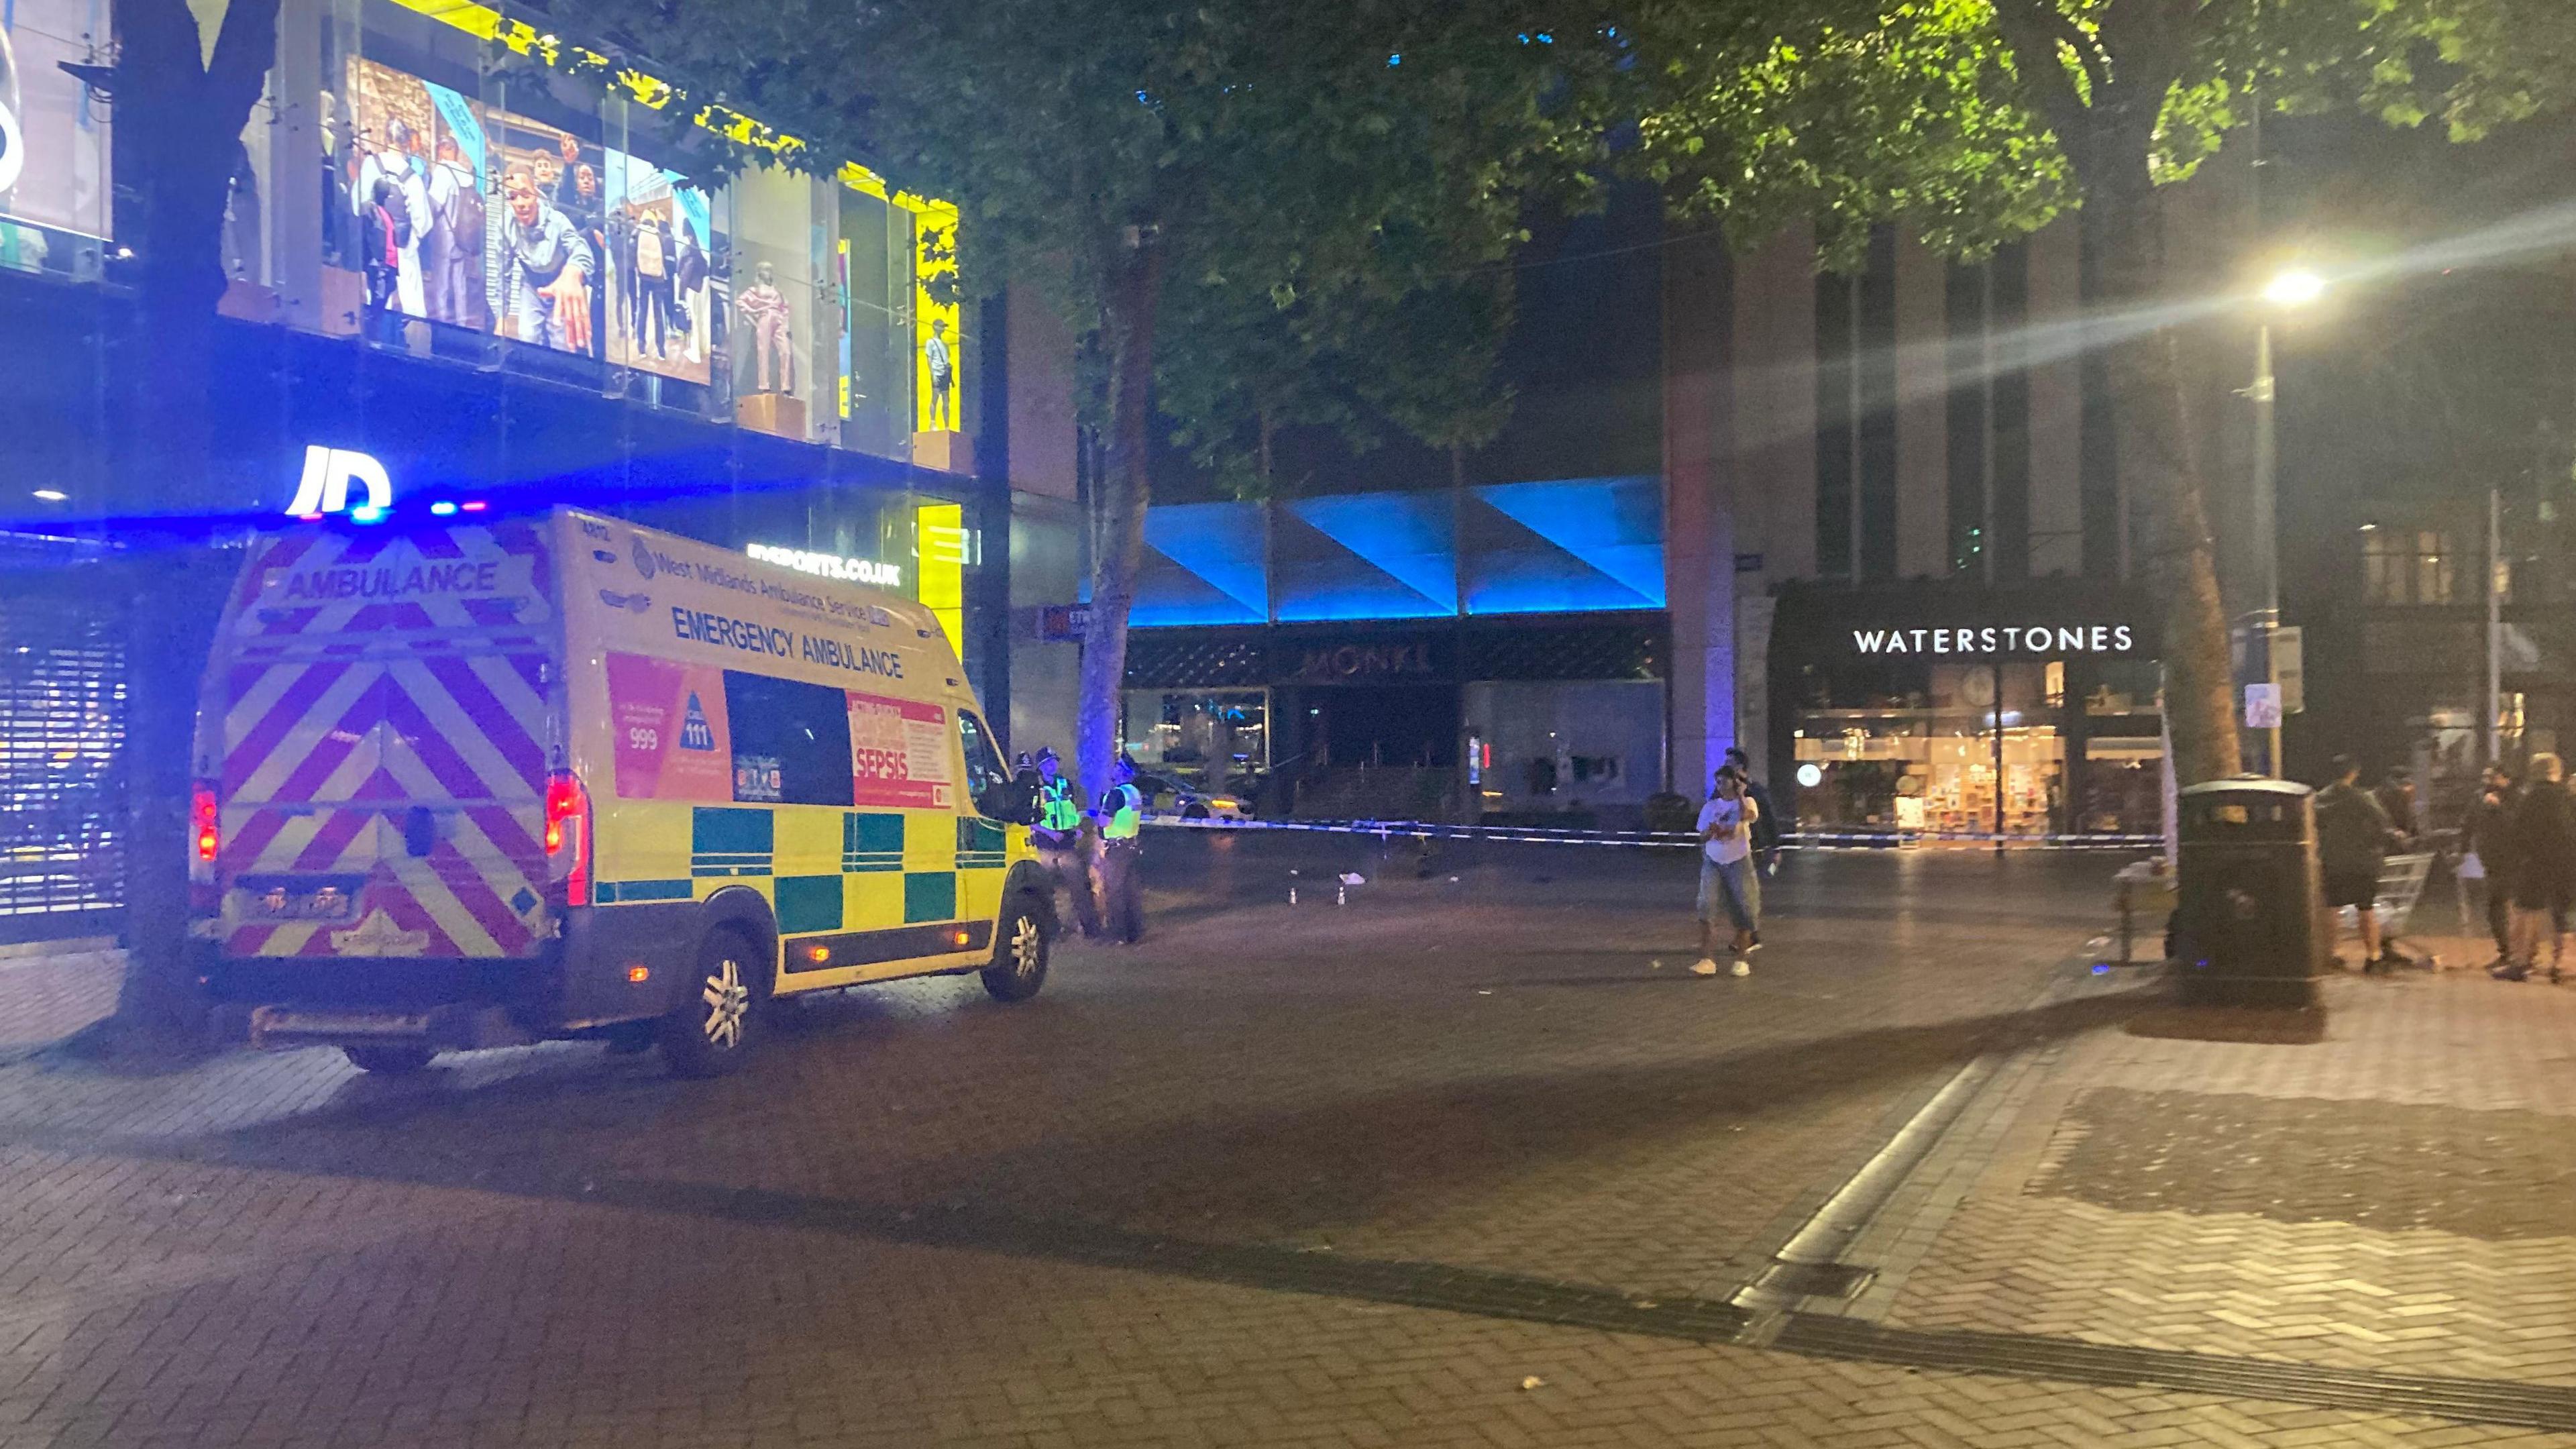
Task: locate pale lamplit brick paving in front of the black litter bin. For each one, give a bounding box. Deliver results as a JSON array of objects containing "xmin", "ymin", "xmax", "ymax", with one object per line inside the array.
[{"xmin": 1880, "ymin": 922, "xmax": 2576, "ymax": 1385}]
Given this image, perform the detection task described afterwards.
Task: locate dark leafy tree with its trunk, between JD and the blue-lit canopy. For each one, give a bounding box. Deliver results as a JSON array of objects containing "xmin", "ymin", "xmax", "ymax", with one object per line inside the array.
[{"xmin": 567, "ymin": 0, "xmax": 1620, "ymax": 835}]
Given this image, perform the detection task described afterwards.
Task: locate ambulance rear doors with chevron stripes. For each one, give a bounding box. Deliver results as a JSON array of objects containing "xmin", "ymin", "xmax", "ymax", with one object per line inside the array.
[{"xmin": 199, "ymin": 521, "xmax": 561, "ymax": 959}]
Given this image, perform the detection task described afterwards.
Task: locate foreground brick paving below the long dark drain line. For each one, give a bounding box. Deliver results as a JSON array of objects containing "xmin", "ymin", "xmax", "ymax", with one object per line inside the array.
[{"xmin": 0, "ymin": 1139, "xmax": 2553, "ymax": 1449}]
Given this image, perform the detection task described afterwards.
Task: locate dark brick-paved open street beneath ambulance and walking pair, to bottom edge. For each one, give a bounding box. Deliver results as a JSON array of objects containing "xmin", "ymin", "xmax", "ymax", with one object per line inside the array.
[{"xmin": 0, "ymin": 846, "xmax": 2576, "ymax": 1449}]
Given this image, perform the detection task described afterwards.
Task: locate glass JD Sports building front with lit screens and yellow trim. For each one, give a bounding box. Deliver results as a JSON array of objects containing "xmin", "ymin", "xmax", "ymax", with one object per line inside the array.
[{"xmin": 0, "ymin": 0, "xmax": 1077, "ymax": 938}]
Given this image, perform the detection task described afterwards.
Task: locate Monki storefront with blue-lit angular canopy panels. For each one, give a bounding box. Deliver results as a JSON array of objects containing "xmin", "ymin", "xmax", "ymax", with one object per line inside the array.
[{"xmin": 1123, "ymin": 477, "xmax": 1669, "ymax": 822}]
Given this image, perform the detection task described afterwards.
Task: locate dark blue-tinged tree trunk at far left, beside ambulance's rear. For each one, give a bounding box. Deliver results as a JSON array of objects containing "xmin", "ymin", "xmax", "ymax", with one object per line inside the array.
[{"xmin": 113, "ymin": 0, "xmax": 278, "ymax": 1036}]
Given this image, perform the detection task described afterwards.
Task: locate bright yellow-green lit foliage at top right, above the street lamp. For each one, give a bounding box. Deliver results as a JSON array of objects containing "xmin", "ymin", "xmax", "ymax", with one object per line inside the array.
[{"xmin": 1638, "ymin": 0, "xmax": 2576, "ymax": 263}]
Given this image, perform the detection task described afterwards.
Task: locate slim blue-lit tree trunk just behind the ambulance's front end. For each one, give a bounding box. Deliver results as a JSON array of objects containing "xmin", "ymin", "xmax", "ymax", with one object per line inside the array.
[{"xmin": 1074, "ymin": 237, "xmax": 1162, "ymax": 892}]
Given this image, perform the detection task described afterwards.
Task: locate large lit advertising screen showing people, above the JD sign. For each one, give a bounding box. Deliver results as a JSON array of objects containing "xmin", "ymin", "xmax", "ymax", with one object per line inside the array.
[{"xmin": 340, "ymin": 59, "xmax": 724, "ymax": 384}]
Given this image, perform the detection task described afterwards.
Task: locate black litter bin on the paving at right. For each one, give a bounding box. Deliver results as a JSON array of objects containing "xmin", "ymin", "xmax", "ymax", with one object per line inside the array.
[{"xmin": 2174, "ymin": 776, "xmax": 2326, "ymax": 1006}]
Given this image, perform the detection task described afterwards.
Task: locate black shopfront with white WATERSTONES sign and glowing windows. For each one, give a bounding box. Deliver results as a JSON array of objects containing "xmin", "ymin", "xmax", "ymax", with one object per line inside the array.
[{"xmin": 1770, "ymin": 580, "xmax": 2164, "ymax": 835}]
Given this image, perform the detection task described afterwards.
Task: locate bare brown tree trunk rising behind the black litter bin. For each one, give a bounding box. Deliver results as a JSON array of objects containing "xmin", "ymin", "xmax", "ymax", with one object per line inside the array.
[{"xmin": 2076, "ymin": 155, "xmax": 2244, "ymax": 784}]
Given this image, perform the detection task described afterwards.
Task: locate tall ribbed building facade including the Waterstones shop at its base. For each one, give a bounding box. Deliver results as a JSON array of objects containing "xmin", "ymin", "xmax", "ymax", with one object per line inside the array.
[{"xmin": 1664, "ymin": 224, "xmax": 2236, "ymax": 835}]
